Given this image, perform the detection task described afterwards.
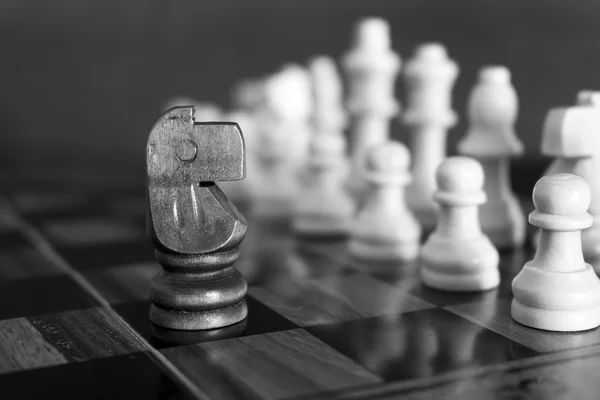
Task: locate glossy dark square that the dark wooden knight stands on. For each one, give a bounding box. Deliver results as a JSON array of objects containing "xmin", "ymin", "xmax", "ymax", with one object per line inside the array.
[{"xmin": 114, "ymin": 296, "xmax": 298, "ymax": 348}]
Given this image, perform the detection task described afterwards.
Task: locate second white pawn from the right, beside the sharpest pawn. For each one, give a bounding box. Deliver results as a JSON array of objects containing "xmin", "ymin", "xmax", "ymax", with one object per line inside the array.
[{"xmin": 421, "ymin": 157, "xmax": 500, "ymax": 292}]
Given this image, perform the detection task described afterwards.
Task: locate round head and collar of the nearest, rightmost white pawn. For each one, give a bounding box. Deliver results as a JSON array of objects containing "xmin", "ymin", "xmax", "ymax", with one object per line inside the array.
[{"xmin": 529, "ymin": 174, "xmax": 592, "ymax": 231}]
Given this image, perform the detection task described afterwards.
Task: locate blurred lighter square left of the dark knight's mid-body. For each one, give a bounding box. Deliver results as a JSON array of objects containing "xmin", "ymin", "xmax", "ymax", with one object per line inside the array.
[{"xmin": 41, "ymin": 217, "xmax": 146, "ymax": 246}]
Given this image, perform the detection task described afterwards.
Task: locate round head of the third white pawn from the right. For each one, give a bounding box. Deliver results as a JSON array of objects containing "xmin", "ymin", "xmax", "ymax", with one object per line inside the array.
[{"xmin": 365, "ymin": 141, "xmax": 410, "ymax": 183}]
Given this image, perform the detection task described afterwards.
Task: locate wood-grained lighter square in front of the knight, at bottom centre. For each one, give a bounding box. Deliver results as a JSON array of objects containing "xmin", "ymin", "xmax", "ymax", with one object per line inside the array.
[{"xmin": 163, "ymin": 329, "xmax": 380, "ymax": 400}]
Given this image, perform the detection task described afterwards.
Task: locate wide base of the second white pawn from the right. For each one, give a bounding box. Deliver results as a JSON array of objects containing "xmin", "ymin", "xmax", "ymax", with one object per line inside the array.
[{"xmin": 421, "ymin": 233, "xmax": 500, "ymax": 292}]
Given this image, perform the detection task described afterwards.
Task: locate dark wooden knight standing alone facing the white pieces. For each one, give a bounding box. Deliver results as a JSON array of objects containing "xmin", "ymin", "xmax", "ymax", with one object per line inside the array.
[{"xmin": 147, "ymin": 107, "xmax": 247, "ymax": 330}]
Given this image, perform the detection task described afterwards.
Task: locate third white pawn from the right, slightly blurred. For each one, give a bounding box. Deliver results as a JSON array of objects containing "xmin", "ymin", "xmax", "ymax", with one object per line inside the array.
[{"xmin": 349, "ymin": 142, "xmax": 421, "ymax": 261}]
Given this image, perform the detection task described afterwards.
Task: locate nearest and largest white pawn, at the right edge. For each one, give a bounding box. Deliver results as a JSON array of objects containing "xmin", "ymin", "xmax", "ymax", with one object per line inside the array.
[{"xmin": 511, "ymin": 174, "xmax": 600, "ymax": 332}]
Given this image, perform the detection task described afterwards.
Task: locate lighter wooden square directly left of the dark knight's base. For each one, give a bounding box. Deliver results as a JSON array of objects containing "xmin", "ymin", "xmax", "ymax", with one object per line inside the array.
[{"xmin": 83, "ymin": 261, "xmax": 161, "ymax": 304}]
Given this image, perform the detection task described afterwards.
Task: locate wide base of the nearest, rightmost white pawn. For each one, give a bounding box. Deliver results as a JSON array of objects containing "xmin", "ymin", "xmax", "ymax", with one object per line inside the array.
[{"xmin": 511, "ymin": 263, "xmax": 600, "ymax": 332}]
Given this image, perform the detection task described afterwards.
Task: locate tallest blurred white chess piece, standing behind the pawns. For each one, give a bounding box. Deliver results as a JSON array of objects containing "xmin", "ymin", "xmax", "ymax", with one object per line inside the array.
[{"xmin": 342, "ymin": 18, "xmax": 401, "ymax": 199}]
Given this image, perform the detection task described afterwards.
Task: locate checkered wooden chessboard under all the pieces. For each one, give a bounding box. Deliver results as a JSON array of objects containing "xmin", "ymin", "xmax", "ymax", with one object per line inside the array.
[{"xmin": 0, "ymin": 168, "xmax": 600, "ymax": 400}]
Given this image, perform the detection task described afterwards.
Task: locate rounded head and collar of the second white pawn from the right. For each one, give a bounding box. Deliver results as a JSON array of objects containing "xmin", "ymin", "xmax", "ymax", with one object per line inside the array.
[{"xmin": 435, "ymin": 156, "xmax": 486, "ymax": 205}]
